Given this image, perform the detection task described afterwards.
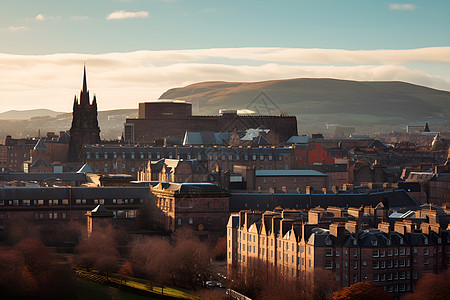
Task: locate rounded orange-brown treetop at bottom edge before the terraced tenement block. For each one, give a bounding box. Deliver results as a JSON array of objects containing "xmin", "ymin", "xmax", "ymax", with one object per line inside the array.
[{"xmin": 332, "ymin": 281, "xmax": 392, "ymax": 300}]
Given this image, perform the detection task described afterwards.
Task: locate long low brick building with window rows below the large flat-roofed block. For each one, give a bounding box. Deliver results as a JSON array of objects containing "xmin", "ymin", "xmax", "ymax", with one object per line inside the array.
[{"xmin": 83, "ymin": 144, "xmax": 293, "ymax": 180}]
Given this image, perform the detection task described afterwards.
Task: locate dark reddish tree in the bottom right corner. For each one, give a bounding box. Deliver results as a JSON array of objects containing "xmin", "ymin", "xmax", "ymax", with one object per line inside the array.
[{"xmin": 406, "ymin": 269, "xmax": 450, "ymax": 300}]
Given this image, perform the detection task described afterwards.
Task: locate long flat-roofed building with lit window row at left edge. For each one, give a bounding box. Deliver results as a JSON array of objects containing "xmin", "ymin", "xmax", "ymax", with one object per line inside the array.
[{"xmin": 0, "ymin": 186, "xmax": 153, "ymax": 240}]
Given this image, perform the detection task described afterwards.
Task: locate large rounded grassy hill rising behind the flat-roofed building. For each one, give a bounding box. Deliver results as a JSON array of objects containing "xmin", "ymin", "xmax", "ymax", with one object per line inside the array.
[{"xmin": 160, "ymin": 78, "xmax": 450, "ymax": 134}]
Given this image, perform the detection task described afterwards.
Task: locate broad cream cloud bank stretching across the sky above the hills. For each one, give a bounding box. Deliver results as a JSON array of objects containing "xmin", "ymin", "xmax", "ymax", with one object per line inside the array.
[{"xmin": 0, "ymin": 47, "xmax": 450, "ymax": 111}]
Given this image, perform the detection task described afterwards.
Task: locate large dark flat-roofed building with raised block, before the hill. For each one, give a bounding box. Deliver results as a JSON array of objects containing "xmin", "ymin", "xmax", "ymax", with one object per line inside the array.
[{"xmin": 124, "ymin": 100, "xmax": 297, "ymax": 144}]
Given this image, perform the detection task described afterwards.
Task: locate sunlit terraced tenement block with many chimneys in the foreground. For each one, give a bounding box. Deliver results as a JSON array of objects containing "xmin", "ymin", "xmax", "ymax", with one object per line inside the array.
[{"xmin": 227, "ymin": 209, "xmax": 450, "ymax": 296}]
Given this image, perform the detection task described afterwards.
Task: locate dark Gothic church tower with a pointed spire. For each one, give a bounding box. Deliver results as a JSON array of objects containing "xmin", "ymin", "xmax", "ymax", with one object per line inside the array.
[{"xmin": 68, "ymin": 66, "xmax": 100, "ymax": 162}]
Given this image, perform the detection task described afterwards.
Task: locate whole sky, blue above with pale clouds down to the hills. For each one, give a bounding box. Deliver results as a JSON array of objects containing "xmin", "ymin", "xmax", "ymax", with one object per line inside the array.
[{"xmin": 0, "ymin": 0, "xmax": 450, "ymax": 112}]
